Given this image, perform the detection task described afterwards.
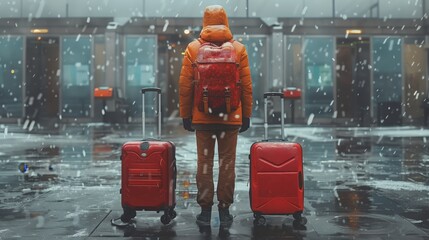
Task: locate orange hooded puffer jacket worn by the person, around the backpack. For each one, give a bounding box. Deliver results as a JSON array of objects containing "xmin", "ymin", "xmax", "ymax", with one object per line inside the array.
[{"xmin": 179, "ymin": 6, "xmax": 253, "ymax": 126}]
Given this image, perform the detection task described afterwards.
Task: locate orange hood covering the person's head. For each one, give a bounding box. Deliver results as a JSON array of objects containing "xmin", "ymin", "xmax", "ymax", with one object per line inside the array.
[{"xmin": 200, "ymin": 5, "xmax": 232, "ymax": 43}]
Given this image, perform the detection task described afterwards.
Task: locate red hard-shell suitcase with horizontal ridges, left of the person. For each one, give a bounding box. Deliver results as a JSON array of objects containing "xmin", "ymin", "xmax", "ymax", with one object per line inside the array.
[{"xmin": 113, "ymin": 88, "xmax": 176, "ymax": 224}]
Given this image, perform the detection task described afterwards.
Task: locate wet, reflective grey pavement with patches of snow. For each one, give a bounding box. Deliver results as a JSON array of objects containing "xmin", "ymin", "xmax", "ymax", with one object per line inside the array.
[{"xmin": 0, "ymin": 122, "xmax": 429, "ymax": 239}]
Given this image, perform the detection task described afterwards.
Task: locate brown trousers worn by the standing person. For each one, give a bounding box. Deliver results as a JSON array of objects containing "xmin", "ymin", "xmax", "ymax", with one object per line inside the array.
[{"xmin": 196, "ymin": 129, "xmax": 238, "ymax": 208}]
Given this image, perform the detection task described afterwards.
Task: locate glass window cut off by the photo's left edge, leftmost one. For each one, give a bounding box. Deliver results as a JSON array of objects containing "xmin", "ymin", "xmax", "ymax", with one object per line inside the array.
[{"xmin": 0, "ymin": 36, "xmax": 23, "ymax": 118}]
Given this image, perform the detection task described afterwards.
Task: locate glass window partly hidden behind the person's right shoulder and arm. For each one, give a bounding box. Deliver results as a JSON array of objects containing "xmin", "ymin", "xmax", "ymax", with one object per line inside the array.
[{"xmin": 235, "ymin": 36, "xmax": 268, "ymax": 117}]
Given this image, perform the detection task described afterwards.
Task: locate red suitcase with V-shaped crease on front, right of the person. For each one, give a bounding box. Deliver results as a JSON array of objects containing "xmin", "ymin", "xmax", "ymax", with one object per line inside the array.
[{"xmin": 250, "ymin": 92, "xmax": 307, "ymax": 225}]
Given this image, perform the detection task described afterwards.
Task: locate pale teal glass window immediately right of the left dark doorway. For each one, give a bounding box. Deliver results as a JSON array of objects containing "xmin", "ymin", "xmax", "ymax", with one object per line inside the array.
[{"xmin": 61, "ymin": 35, "xmax": 92, "ymax": 117}]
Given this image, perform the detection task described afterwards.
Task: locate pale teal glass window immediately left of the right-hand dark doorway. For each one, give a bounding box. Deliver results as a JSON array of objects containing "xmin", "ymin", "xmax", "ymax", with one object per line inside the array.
[{"xmin": 303, "ymin": 37, "xmax": 334, "ymax": 116}]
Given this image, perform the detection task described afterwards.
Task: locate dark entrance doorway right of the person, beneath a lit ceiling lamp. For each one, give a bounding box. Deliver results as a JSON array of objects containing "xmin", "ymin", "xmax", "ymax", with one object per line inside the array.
[{"xmin": 336, "ymin": 38, "xmax": 371, "ymax": 126}]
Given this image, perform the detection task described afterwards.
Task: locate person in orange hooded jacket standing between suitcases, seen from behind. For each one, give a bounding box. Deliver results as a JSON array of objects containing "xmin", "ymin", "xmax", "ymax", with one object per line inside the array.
[{"xmin": 179, "ymin": 5, "xmax": 252, "ymax": 226}]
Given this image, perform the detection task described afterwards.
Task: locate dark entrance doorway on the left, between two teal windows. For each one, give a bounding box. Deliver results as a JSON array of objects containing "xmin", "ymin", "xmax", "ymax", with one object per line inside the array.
[{"xmin": 25, "ymin": 37, "xmax": 59, "ymax": 124}]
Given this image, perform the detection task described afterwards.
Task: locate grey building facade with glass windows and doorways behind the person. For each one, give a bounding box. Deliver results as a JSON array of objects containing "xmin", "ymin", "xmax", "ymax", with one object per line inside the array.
[{"xmin": 0, "ymin": 0, "xmax": 429, "ymax": 126}]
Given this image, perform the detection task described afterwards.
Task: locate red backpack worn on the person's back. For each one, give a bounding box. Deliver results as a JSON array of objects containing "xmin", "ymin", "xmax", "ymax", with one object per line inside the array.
[{"xmin": 193, "ymin": 42, "xmax": 241, "ymax": 114}]
